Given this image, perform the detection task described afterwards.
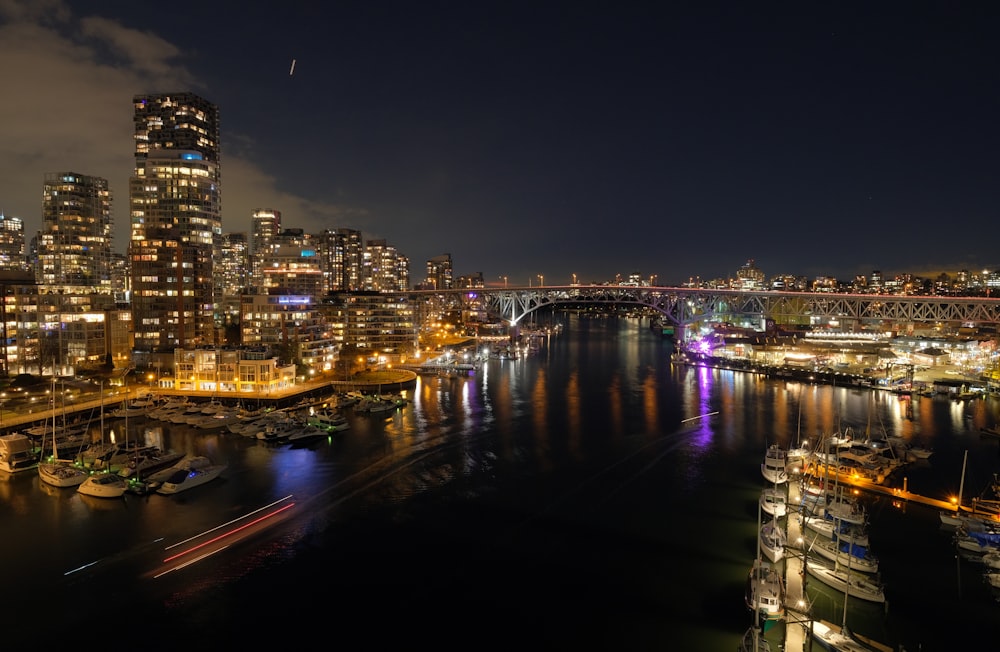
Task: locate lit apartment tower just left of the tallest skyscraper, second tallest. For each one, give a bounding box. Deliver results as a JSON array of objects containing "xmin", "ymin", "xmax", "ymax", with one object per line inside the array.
[{"xmin": 36, "ymin": 172, "xmax": 112, "ymax": 294}]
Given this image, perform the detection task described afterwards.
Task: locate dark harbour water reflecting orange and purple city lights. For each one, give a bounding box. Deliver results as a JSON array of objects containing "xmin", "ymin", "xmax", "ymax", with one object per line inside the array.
[{"xmin": 0, "ymin": 313, "xmax": 1000, "ymax": 651}]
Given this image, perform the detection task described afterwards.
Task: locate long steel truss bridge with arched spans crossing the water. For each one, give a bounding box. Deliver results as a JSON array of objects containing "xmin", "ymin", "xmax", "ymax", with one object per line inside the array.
[{"xmin": 409, "ymin": 285, "xmax": 1000, "ymax": 332}]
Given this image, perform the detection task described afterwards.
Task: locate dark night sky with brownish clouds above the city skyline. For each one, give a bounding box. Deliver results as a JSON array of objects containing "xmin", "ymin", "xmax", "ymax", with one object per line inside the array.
[{"xmin": 0, "ymin": 0, "xmax": 1000, "ymax": 285}]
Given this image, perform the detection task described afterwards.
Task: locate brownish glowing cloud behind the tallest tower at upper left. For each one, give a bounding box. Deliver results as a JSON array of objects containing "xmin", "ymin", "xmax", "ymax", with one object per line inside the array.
[{"xmin": 0, "ymin": 0, "xmax": 340, "ymax": 252}]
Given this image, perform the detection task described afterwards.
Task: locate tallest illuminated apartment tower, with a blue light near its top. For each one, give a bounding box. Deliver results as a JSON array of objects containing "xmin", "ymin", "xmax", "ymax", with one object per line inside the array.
[{"xmin": 129, "ymin": 93, "xmax": 222, "ymax": 351}]
